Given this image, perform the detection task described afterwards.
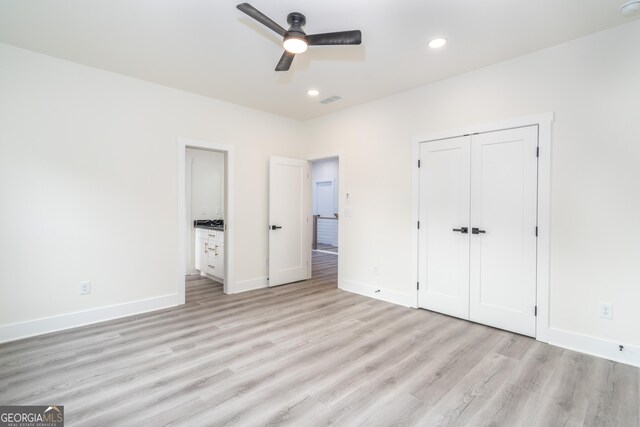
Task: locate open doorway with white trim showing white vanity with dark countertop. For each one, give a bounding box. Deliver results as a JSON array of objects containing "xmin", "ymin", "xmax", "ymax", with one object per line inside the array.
[{"xmin": 178, "ymin": 138, "xmax": 235, "ymax": 303}]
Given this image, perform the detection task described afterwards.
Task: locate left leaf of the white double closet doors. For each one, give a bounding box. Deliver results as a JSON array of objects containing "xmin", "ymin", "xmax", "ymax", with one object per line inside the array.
[{"xmin": 418, "ymin": 137, "xmax": 470, "ymax": 319}]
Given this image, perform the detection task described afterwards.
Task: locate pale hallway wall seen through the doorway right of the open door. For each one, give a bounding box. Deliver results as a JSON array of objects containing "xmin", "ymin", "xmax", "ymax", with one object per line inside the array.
[{"xmin": 311, "ymin": 157, "xmax": 340, "ymax": 246}]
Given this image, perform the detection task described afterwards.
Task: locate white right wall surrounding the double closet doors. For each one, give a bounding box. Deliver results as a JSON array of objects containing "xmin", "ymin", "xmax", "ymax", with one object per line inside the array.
[{"xmin": 306, "ymin": 21, "xmax": 640, "ymax": 352}]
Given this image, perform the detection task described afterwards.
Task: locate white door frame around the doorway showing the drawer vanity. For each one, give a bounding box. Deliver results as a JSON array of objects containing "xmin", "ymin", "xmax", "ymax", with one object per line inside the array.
[{"xmin": 177, "ymin": 137, "xmax": 235, "ymax": 298}]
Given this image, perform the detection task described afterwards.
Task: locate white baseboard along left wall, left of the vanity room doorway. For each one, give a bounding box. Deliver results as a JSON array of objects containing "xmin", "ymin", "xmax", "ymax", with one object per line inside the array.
[{"xmin": 0, "ymin": 294, "xmax": 181, "ymax": 343}]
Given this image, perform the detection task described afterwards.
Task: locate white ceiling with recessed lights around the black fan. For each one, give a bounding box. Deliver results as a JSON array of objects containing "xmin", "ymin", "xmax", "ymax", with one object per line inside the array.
[{"xmin": 0, "ymin": 0, "xmax": 628, "ymax": 120}]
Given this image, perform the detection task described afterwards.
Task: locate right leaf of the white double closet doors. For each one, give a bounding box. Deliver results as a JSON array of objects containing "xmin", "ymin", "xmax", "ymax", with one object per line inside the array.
[{"xmin": 470, "ymin": 126, "xmax": 538, "ymax": 336}]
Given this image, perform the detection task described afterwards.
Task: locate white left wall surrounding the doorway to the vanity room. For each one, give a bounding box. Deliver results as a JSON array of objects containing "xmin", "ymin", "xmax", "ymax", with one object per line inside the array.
[{"xmin": 0, "ymin": 44, "xmax": 303, "ymax": 338}]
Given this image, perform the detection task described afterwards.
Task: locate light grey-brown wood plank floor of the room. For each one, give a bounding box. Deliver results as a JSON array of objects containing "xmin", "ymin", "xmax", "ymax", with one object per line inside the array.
[{"xmin": 0, "ymin": 253, "xmax": 640, "ymax": 426}]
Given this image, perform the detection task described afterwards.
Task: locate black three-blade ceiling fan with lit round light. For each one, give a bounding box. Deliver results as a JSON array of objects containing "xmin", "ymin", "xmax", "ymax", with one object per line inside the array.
[{"xmin": 237, "ymin": 3, "xmax": 362, "ymax": 71}]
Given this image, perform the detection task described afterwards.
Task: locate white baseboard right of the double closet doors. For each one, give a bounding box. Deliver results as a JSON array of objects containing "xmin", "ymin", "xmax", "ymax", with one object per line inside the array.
[{"xmin": 549, "ymin": 328, "xmax": 640, "ymax": 367}]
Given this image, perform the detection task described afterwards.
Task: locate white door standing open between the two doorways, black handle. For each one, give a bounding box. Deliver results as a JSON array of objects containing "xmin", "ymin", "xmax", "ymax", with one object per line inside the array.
[{"xmin": 269, "ymin": 157, "xmax": 311, "ymax": 286}]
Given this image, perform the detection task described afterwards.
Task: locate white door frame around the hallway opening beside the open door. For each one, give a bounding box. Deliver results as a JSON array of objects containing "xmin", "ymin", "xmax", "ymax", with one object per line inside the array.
[{"xmin": 306, "ymin": 151, "xmax": 347, "ymax": 289}]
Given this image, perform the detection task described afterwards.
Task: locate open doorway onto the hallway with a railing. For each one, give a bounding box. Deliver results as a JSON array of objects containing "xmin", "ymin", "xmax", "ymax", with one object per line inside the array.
[{"xmin": 311, "ymin": 157, "xmax": 340, "ymax": 282}]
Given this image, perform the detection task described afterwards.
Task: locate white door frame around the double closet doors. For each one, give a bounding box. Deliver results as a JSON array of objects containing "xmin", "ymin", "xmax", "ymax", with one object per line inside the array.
[{"xmin": 412, "ymin": 112, "xmax": 554, "ymax": 343}]
